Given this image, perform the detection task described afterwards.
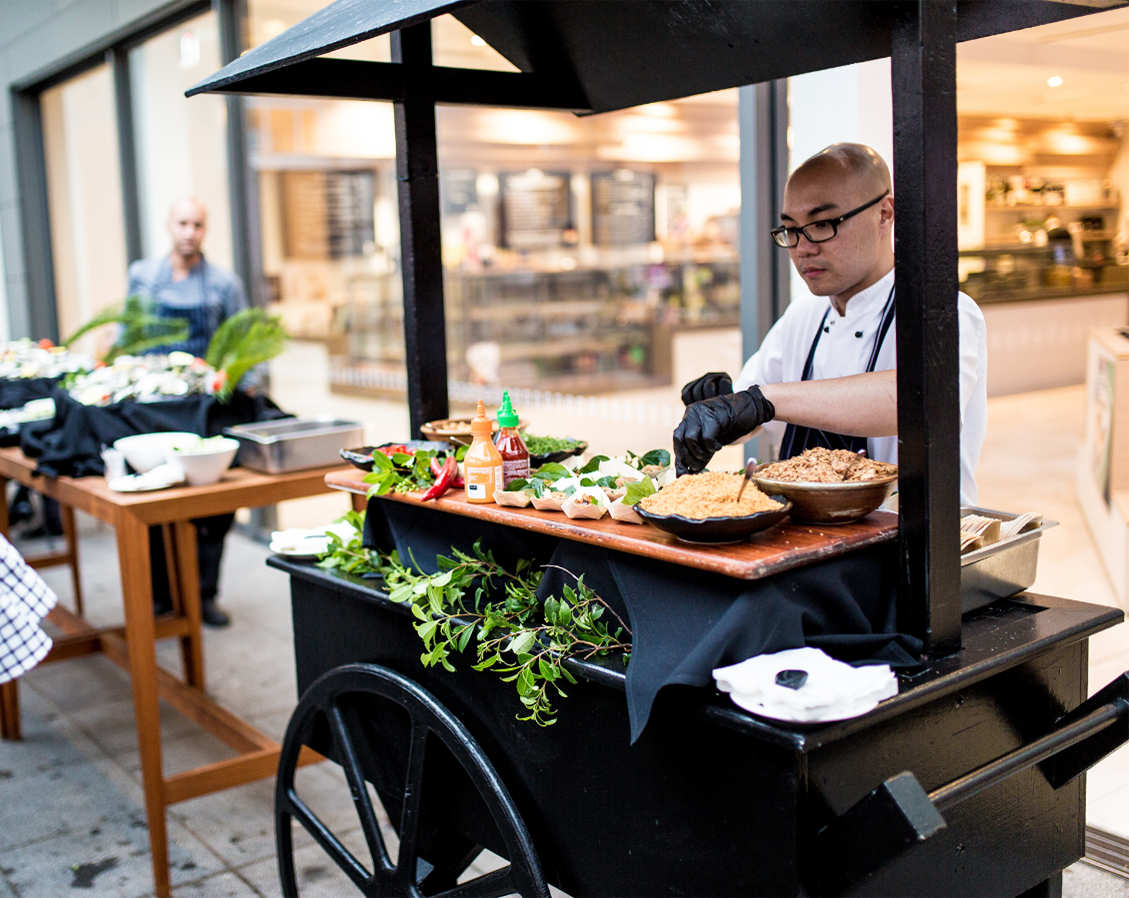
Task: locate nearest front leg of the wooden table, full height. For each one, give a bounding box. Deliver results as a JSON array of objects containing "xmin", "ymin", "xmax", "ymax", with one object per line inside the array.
[{"xmin": 116, "ymin": 514, "xmax": 169, "ymax": 898}]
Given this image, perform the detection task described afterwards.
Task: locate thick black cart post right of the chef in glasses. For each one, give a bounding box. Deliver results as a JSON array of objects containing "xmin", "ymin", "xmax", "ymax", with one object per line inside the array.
[{"xmin": 891, "ymin": 0, "xmax": 961, "ymax": 657}]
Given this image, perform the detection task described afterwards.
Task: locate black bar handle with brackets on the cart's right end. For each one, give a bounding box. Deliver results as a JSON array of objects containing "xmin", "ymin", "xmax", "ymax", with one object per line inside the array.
[{"xmin": 816, "ymin": 672, "xmax": 1129, "ymax": 895}]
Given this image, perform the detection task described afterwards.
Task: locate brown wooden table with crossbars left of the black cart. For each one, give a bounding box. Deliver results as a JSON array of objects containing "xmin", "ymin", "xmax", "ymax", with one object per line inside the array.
[{"xmin": 0, "ymin": 448, "xmax": 356, "ymax": 898}]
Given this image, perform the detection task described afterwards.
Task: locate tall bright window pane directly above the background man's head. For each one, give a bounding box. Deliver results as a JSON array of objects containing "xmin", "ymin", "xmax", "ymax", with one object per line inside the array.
[{"xmin": 130, "ymin": 12, "xmax": 233, "ymax": 270}]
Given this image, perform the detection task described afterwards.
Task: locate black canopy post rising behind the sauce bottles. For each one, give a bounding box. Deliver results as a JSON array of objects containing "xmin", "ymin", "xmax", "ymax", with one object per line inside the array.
[{"xmin": 392, "ymin": 23, "xmax": 449, "ymax": 438}]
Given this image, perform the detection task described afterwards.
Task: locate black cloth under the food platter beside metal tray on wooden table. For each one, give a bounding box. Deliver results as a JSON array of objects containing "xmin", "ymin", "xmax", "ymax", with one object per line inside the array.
[{"xmin": 19, "ymin": 389, "xmax": 291, "ymax": 477}]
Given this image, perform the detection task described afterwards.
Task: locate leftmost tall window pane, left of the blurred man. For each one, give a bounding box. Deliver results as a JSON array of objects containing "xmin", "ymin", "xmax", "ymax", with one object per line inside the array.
[{"xmin": 40, "ymin": 66, "xmax": 126, "ymax": 338}]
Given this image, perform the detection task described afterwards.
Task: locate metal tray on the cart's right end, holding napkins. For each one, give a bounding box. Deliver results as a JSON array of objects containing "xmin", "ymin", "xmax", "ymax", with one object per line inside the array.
[{"xmin": 961, "ymin": 505, "xmax": 1058, "ymax": 613}]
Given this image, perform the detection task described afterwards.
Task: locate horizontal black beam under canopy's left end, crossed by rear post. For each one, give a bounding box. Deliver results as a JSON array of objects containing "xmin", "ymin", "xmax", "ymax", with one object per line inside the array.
[{"xmin": 203, "ymin": 58, "xmax": 588, "ymax": 112}]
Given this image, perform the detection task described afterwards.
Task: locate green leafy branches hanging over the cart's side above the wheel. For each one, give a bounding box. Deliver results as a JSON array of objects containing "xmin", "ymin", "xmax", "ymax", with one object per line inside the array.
[{"xmin": 318, "ymin": 512, "xmax": 631, "ymax": 726}]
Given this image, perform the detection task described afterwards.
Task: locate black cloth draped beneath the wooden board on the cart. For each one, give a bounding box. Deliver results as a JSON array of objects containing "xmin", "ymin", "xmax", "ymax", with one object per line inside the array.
[{"xmin": 365, "ymin": 499, "xmax": 921, "ymax": 742}]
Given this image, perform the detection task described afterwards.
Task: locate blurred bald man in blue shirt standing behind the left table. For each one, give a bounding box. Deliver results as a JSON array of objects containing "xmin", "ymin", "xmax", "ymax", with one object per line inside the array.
[{"xmin": 129, "ymin": 197, "xmax": 247, "ymax": 627}]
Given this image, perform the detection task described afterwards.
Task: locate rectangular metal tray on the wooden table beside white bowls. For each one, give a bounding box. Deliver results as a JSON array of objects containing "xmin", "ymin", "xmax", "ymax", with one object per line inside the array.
[{"xmin": 224, "ymin": 418, "xmax": 365, "ymax": 474}]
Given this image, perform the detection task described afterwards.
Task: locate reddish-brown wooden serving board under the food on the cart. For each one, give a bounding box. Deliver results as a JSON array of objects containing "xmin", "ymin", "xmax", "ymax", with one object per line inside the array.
[{"xmin": 325, "ymin": 471, "xmax": 898, "ymax": 579}]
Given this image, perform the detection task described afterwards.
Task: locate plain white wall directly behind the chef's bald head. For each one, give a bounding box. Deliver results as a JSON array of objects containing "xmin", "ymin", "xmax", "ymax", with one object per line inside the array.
[{"xmin": 788, "ymin": 59, "xmax": 894, "ymax": 304}]
